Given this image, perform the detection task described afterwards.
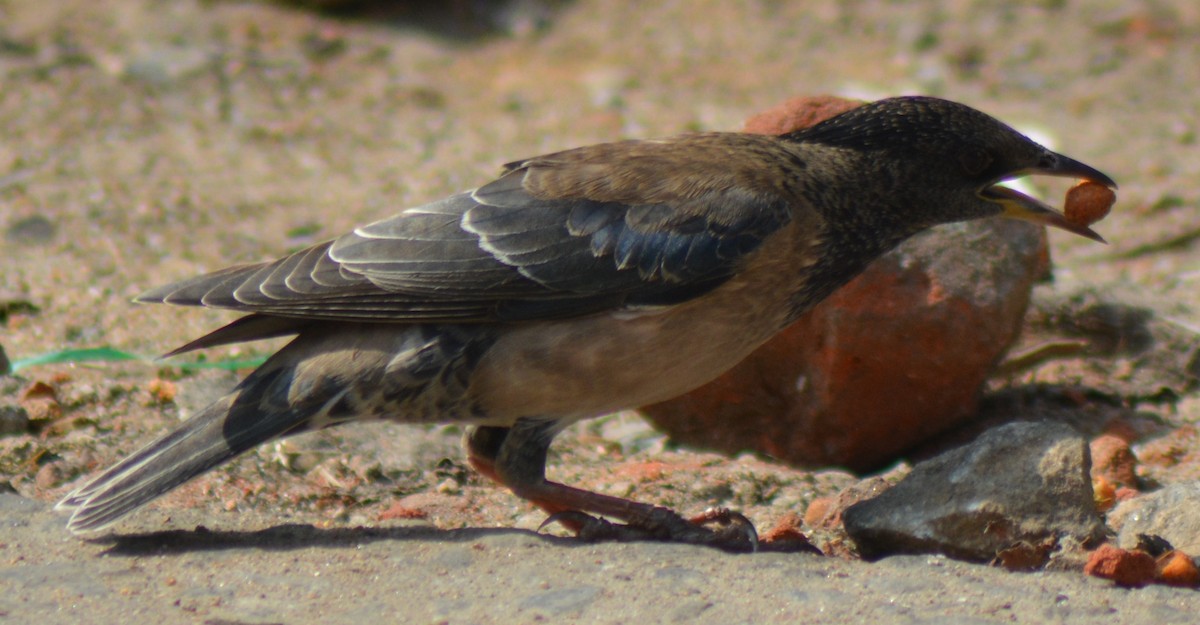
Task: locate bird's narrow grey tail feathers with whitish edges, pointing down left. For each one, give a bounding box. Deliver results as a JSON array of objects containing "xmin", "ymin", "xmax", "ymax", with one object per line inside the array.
[{"xmin": 55, "ymin": 366, "xmax": 319, "ymax": 534}]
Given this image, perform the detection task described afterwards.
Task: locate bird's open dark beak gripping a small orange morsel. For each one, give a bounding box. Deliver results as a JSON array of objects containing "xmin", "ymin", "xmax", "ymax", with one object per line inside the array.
[{"xmin": 979, "ymin": 150, "xmax": 1117, "ymax": 244}]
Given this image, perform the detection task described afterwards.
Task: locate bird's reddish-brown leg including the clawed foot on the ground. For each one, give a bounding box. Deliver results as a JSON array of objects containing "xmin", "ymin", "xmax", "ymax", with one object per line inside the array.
[{"xmin": 464, "ymin": 420, "xmax": 757, "ymax": 552}]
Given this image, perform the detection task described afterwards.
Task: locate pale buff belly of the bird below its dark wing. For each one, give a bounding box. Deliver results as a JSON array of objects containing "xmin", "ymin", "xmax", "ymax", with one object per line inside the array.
[{"xmin": 470, "ymin": 273, "xmax": 787, "ymax": 422}]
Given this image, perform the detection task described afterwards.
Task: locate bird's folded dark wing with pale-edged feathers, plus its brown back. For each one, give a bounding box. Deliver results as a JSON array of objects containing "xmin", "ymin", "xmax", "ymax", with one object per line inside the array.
[{"xmin": 138, "ymin": 136, "xmax": 791, "ymax": 323}]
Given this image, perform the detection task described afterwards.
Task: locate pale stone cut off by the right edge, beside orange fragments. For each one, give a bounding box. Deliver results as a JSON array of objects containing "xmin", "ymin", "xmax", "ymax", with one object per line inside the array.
[{"xmin": 1109, "ymin": 482, "xmax": 1200, "ymax": 557}]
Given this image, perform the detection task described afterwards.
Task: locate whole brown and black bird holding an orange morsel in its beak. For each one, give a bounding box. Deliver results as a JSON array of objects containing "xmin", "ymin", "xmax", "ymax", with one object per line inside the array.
[{"xmin": 56, "ymin": 96, "xmax": 1116, "ymax": 551}]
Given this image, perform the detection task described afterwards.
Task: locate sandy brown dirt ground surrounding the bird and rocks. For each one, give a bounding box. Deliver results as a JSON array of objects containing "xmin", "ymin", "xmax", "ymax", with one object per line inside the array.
[{"xmin": 0, "ymin": 0, "xmax": 1200, "ymax": 624}]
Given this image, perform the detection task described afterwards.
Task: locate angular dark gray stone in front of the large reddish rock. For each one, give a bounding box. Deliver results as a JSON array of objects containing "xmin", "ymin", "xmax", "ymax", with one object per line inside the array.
[{"xmin": 842, "ymin": 422, "xmax": 1104, "ymax": 560}]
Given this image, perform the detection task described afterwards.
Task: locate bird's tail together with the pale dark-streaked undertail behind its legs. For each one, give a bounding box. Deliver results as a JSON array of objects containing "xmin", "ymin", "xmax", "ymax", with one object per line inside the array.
[{"xmin": 56, "ymin": 324, "xmax": 477, "ymax": 534}]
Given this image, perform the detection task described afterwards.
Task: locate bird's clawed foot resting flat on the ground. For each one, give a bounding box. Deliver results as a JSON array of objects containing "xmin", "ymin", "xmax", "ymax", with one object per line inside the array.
[{"xmin": 538, "ymin": 507, "xmax": 758, "ymax": 553}]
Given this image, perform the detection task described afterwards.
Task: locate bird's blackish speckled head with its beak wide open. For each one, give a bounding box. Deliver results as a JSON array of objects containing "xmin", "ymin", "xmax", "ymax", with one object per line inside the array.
[{"xmin": 786, "ymin": 96, "xmax": 1117, "ymax": 242}]
